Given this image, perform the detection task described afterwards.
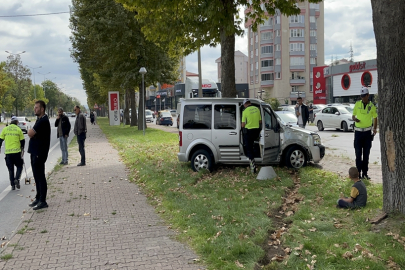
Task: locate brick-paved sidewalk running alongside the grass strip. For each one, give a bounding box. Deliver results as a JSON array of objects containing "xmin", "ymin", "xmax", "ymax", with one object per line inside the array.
[{"xmin": 0, "ymin": 124, "xmax": 202, "ymax": 270}]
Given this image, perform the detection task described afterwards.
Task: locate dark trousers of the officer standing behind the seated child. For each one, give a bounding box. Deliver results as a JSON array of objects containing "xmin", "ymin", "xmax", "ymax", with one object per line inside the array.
[{"xmin": 354, "ymin": 130, "xmax": 373, "ymax": 176}]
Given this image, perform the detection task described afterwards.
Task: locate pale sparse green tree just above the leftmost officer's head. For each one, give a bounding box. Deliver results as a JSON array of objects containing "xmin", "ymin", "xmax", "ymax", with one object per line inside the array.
[{"xmin": 5, "ymin": 54, "xmax": 31, "ymax": 115}]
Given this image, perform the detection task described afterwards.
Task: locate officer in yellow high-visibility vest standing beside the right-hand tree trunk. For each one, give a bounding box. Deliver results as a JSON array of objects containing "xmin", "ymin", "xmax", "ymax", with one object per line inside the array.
[{"xmin": 352, "ymin": 87, "xmax": 378, "ymax": 179}]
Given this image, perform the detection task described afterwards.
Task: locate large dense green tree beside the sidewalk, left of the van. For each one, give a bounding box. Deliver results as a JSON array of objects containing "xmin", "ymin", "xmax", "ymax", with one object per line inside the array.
[{"xmin": 70, "ymin": 0, "xmax": 178, "ymax": 129}]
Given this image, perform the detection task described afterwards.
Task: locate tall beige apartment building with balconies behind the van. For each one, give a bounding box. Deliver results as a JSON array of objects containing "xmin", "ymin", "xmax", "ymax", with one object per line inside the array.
[{"xmin": 245, "ymin": 1, "xmax": 324, "ymax": 104}]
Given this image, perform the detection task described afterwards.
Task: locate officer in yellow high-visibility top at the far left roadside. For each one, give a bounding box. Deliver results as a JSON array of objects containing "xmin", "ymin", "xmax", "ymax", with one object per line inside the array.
[{"xmin": 0, "ymin": 116, "xmax": 25, "ymax": 190}]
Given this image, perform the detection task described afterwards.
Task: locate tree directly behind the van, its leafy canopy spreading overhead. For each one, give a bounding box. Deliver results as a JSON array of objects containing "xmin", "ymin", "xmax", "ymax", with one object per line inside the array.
[{"xmin": 116, "ymin": 0, "xmax": 321, "ymax": 97}]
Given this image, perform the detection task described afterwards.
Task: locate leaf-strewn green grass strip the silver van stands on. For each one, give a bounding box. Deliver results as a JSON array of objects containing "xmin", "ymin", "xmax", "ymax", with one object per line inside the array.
[{"xmin": 98, "ymin": 118, "xmax": 405, "ymax": 269}]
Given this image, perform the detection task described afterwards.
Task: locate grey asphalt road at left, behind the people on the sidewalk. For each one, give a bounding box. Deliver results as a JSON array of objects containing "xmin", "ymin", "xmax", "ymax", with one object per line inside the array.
[{"xmin": 0, "ymin": 118, "xmax": 76, "ymax": 239}]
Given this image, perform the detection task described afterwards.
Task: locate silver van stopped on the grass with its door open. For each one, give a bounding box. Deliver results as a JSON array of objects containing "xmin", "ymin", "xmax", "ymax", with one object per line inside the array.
[{"xmin": 177, "ymin": 98, "xmax": 325, "ymax": 171}]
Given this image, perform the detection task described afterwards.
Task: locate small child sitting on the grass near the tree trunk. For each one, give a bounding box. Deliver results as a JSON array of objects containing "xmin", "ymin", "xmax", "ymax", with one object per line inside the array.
[{"xmin": 336, "ymin": 167, "xmax": 367, "ymax": 209}]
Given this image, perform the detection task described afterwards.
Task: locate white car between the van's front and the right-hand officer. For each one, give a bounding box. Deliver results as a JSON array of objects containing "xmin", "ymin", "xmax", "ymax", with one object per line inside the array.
[{"xmin": 314, "ymin": 106, "xmax": 354, "ymax": 132}]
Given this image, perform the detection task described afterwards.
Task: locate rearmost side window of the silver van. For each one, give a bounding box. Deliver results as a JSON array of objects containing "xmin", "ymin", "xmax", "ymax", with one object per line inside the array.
[{"xmin": 183, "ymin": 105, "xmax": 212, "ymax": 129}]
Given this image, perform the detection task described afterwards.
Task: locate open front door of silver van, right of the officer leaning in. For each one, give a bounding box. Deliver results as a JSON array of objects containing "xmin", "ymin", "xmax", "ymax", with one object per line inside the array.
[{"xmin": 260, "ymin": 105, "xmax": 280, "ymax": 164}]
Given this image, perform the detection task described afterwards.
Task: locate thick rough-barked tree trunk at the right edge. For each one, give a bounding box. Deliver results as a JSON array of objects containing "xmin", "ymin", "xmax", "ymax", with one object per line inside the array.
[{"xmin": 371, "ymin": 0, "xmax": 405, "ymax": 214}]
